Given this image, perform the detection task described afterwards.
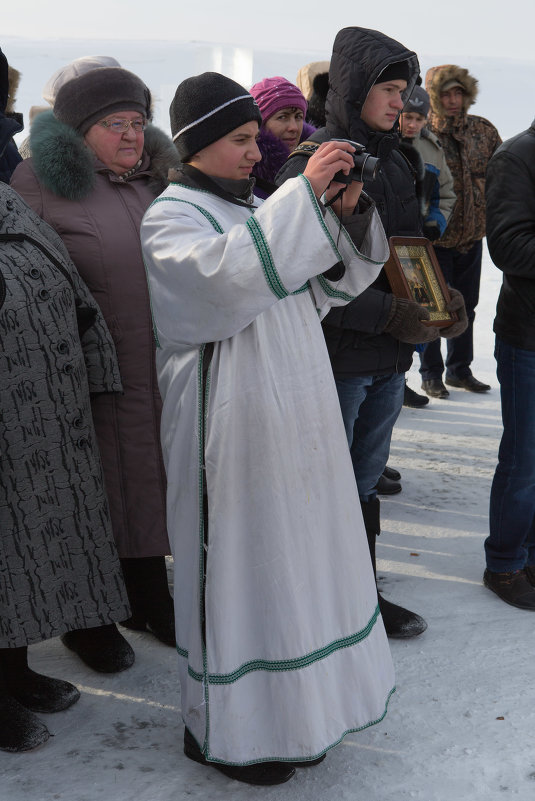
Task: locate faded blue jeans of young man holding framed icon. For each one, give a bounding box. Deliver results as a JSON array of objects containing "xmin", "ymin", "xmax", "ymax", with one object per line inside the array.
[{"xmin": 336, "ymin": 373, "xmax": 405, "ymax": 501}]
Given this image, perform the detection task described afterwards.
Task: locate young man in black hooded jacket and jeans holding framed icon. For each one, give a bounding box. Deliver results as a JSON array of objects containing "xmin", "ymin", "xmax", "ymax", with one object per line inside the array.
[{"xmin": 276, "ymin": 28, "xmax": 463, "ymax": 637}]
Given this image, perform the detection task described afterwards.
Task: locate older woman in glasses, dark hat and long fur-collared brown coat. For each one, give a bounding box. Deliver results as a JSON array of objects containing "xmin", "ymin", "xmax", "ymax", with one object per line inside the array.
[{"xmin": 12, "ymin": 67, "xmax": 182, "ymax": 658}]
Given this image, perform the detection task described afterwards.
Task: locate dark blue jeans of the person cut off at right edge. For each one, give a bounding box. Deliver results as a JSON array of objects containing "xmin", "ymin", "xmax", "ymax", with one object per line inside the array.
[{"xmin": 485, "ymin": 337, "xmax": 535, "ymax": 573}]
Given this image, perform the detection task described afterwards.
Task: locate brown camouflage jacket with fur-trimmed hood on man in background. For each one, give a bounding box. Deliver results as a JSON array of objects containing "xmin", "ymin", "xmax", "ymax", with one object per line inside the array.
[{"xmin": 426, "ymin": 64, "xmax": 502, "ymax": 253}]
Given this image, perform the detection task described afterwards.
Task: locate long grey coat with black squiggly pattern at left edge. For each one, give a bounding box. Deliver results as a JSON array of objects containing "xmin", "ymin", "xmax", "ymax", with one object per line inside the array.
[{"xmin": 0, "ymin": 183, "xmax": 129, "ymax": 648}]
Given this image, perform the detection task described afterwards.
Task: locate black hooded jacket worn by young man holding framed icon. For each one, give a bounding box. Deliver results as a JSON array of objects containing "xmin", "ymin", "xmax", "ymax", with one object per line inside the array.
[{"xmin": 277, "ymin": 28, "xmax": 421, "ymax": 376}]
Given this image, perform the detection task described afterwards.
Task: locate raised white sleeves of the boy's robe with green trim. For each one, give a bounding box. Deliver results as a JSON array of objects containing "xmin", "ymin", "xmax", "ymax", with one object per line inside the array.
[{"xmin": 141, "ymin": 176, "xmax": 388, "ymax": 345}]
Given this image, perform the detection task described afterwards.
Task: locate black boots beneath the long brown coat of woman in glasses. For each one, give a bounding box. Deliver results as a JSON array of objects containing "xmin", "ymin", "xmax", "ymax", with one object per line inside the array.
[{"xmin": 120, "ymin": 556, "xmax": 176, "ymax": 648}]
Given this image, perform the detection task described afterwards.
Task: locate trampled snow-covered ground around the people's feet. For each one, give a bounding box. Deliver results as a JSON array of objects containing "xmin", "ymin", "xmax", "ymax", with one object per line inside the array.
[{"xmin": 0, "ymin": 245, "xmax": 535, "ymax": 801}]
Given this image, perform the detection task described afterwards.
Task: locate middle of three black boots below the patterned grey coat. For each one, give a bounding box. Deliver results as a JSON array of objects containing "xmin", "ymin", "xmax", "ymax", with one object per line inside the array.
[{"xmin": 0, "ymin": 647, "xmax": 80, "ymax": 712}]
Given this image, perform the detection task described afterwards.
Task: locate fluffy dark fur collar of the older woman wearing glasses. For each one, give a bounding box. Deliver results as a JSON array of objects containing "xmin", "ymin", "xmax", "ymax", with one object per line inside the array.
[{"xmin": 30, "ymin": 110, "xmax": 180, "ymax": 200}]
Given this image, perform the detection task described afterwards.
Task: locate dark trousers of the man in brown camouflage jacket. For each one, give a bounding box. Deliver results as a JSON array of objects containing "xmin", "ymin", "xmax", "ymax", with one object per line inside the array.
[{"xmin": 420, "ymin": 240, "xmax": 483, "ymax": 380}]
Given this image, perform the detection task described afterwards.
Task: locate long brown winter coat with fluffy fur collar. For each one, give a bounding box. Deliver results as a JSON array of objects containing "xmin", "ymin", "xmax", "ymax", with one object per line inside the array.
[{"xmin": 12, "ymin": 112, "xmax": 178, "ymax": 558}]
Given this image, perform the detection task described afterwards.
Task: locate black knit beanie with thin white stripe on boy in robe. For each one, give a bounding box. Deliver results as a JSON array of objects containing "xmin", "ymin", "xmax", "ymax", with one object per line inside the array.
[{"xmin": 169, "ymin": 72, "xmax": 262, "ymax": 161}]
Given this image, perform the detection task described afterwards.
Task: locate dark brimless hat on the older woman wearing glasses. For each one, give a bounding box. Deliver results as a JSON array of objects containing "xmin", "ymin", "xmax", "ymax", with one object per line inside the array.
[{"xmin": 54, "ymin": 67, "xmax": 151, "ymax": 136}]
